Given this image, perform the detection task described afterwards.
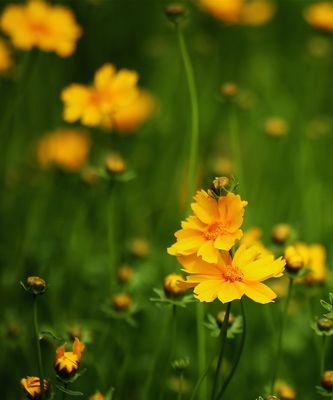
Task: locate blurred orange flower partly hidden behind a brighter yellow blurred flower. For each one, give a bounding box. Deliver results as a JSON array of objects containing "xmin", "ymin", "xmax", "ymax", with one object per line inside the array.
[{"xmin": 114, "ymin": 91, "xmax": 155, "ymax": 133}]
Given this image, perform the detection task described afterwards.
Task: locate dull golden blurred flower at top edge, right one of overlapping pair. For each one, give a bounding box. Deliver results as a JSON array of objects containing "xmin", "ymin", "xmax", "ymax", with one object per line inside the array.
[{"xmin": 241, "ymin": 0, "xmax": 275, "ymax": 26}]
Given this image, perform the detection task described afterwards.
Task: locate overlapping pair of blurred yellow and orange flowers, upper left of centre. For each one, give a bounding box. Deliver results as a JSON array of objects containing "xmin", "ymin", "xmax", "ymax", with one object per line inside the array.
[{"xmin": 61, "ymin": 64, "xmax": 153, "ymax": 132}]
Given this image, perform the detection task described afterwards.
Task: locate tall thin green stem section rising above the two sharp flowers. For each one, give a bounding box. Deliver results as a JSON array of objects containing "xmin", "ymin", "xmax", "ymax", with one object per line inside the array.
[{"xmin": 176, "ymin": 23, "xmax": 199, "ymax": 208}]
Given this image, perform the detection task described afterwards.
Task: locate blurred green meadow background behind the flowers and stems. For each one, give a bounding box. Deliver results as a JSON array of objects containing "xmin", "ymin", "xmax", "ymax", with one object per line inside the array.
[{"xmin": 0, "ymin": 0, "xmax": 333, "ymax": 400}]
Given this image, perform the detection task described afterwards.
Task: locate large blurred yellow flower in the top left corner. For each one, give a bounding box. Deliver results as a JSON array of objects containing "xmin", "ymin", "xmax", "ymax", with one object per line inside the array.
[{"xmin": 0, "ymin": 0, "xmax": 81, "ymax": 57}]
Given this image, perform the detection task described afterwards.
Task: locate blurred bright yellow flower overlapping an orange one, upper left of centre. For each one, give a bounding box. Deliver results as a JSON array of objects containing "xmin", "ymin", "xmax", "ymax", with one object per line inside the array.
[{"xmin": 61, "ymin": 64, "xmax": 139, "ymax": 128}]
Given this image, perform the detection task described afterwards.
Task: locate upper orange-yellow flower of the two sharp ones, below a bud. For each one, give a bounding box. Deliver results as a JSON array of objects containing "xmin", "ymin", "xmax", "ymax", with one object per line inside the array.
[{"xmin": 168, "ymin": 190, "xmax": 247, "ymax": 263}]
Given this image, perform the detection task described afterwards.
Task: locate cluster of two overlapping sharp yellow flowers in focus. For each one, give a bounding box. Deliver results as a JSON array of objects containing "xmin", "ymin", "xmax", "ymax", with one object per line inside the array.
[{"xmin": 168, "ymin": 184, "xmax": 285, "ymax": 304}]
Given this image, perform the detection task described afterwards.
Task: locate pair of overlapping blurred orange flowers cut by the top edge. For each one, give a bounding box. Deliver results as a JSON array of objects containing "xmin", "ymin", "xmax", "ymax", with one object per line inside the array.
[{"xmin": 199, "ymin": 0, "xmax": 275, "ymax": 26}]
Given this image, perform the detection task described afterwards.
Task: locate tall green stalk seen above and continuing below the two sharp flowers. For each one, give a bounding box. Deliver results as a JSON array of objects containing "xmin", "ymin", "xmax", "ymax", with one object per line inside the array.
[{"xmin": 175, "ymin": 17, "xmax": 207, "ymax": 400}]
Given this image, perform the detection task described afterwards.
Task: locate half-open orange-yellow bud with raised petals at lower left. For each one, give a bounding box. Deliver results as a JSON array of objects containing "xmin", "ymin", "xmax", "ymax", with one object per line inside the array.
[{"xmin": 54, "ymin": 338, "xmax": 85, "ymax": 378}]
